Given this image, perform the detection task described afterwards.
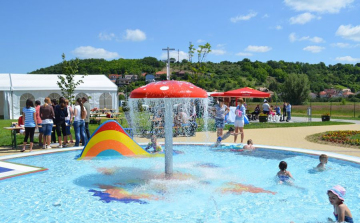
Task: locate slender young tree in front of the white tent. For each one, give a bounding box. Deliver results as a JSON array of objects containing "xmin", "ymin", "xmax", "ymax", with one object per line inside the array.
[{"xmin": 56, "ymin": 53, "xmax": 86, "ymax": 103}]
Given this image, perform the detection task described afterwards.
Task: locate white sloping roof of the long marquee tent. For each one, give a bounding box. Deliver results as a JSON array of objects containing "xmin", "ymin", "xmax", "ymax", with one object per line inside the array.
[{"xmin": 0, "ymin": 74, "xmax": 117, "ymax": 91}]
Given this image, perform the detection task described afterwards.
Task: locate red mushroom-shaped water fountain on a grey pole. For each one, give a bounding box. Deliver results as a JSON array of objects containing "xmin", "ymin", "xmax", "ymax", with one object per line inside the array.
[{"xmin": 130, "ymin": 81, "xmax": 207, "ymax": 177}]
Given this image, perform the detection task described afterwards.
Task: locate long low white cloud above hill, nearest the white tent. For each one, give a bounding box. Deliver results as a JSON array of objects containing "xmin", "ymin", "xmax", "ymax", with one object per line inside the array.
[{"xmin": 72, "ymin": 46, "xmax": 120, "ymax": 59}]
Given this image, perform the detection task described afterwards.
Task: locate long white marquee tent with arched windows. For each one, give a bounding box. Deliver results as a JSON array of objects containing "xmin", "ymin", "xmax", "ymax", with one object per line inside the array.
[{"xmin": 0, "ymin": 74, "xmax": 118, "ymax": 119}]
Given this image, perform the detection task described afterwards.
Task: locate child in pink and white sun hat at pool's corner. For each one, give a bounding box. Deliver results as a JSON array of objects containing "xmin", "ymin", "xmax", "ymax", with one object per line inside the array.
[{"xmin": 327, "ymin": 185, "xmax": 354, "ymax": 223}]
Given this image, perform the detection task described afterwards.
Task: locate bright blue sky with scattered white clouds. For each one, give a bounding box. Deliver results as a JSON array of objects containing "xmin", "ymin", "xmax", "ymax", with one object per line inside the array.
[{"xmin": 0, "ymin": 0, "xmax": 360, "ymax": 73}]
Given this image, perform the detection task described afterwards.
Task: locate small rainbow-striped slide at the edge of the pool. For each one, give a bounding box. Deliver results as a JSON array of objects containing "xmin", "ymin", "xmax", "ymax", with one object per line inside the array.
[{"xmin": 78, "ymin": 120, "xmax": 160, "ymax": 160}]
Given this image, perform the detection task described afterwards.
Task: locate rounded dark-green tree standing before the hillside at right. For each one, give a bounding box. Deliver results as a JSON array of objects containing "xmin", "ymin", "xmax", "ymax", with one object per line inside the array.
[{"xmin": 281, "ymin": 74, "xmax": 310, "ymax": 105}]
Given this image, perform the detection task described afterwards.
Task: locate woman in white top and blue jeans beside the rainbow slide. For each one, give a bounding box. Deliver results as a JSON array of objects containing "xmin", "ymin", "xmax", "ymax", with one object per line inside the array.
[{"xmin": 74, "ymin": 98, "xmax": 87, "ymax": 146}]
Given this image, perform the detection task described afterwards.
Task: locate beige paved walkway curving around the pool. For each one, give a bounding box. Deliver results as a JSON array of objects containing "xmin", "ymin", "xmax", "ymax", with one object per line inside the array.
[{"xmin": 0, "ymin": 117, "xmax": 360, "ymax": 157}]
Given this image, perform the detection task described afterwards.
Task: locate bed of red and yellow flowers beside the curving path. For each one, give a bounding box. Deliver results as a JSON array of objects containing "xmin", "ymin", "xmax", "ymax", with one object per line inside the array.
[{"xmin": 321, "ymin": 131, "xmax": 360, "ymax": 146}]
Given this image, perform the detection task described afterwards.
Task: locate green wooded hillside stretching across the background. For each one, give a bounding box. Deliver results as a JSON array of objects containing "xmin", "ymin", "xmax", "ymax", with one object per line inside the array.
[{"xmin": 31, "ymin": 57, "xmax": 360, "ymax": 93}]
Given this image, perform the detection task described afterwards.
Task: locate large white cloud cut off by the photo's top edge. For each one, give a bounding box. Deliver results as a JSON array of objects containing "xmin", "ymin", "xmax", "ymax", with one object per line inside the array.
[{"xmin": 284, "ymin": 0, "xmax": 354, "ymax": 13}]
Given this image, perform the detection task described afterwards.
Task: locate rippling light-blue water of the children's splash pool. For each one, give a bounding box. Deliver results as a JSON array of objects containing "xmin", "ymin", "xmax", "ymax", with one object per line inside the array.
[{"xmin": 0, "ymin": 145, "xmax": 360, "ymax": 223}]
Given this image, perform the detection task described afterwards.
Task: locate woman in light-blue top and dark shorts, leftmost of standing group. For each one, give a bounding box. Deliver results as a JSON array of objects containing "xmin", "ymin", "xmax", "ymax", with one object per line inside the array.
[{"xmin": 21, "ymin": 99, "xmax": 37, "ymax": 152}]
